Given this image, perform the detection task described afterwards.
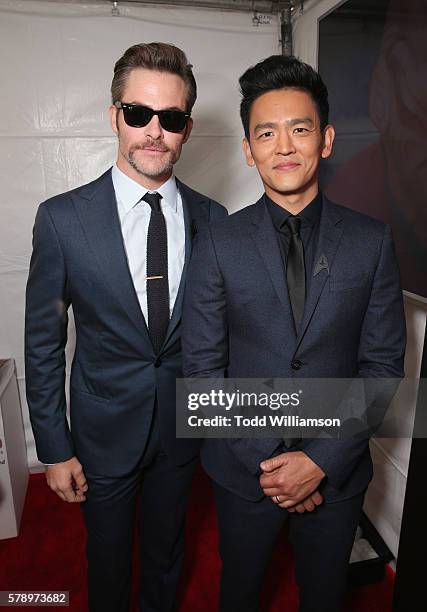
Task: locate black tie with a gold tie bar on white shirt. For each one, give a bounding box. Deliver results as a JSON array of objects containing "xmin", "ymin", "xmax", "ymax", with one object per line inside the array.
[{"xmin": 142, "ymin": 193, "xmax": 169, "ymax": 354}]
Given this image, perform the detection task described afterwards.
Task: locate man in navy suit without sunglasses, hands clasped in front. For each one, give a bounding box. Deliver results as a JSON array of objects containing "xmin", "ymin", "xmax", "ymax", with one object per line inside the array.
[{"xmin": 183, "ymin": 56, "xmax": 405, "ymax": 612}]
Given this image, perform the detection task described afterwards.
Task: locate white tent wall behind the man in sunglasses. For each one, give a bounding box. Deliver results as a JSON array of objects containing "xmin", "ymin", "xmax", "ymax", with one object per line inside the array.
[{"xmin": 0, "ymin": 0, "xmax": 279, "ymax": 468}]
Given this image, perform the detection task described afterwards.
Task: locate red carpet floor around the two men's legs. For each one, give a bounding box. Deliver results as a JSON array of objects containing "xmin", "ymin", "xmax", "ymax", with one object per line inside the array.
[{"xmin": 0, "ymin": 472, "xmax": 394, "ymax": 612}]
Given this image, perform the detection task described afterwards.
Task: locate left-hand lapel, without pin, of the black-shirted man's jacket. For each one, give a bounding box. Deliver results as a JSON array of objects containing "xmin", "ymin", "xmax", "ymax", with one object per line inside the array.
[{"xmin": 251, "ymin": 196, "xmax": 294, "ymax": 329}]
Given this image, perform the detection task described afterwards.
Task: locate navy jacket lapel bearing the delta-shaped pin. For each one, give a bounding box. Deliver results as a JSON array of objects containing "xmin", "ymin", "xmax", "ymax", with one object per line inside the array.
[{"xmin": 297, "ymin": 196, "xmax": 343, "ymax": 348}]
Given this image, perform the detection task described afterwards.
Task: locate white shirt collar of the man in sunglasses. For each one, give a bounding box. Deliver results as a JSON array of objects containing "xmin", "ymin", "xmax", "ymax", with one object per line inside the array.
[{"xmin": 111, "ymin": 164, "xmax": 178, "ymax": 213}]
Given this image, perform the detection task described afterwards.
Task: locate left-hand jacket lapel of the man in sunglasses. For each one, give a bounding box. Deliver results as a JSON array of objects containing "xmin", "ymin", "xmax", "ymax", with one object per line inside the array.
[{"xmin": 73, "ymin": 170, "xmax": 151, "ymax": 346}]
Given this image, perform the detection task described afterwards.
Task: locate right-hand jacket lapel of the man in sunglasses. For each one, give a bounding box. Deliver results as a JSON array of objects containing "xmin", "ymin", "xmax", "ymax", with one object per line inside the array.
[{"xmin": 163, "ymin": 179, "xmax": 209, "ymax": 349}]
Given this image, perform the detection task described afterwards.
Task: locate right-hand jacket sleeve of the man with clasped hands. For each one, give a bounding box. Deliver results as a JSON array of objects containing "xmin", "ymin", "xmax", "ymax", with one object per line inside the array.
[{"xmin": 304, "ymin": 226, "xmax": 406, "ymax": 488}]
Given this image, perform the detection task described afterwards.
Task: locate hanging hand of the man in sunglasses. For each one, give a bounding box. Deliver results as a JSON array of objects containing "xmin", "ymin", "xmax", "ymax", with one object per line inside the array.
[{"xmin": 46, "ymin": 457, "xmax": 88, "ymax": 503}]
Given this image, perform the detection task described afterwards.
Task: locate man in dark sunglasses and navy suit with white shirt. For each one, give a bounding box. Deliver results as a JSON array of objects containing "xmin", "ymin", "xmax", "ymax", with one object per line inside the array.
[{"xmin": 26, "ymin": 43, "xmax": 226, "ymax": 612}]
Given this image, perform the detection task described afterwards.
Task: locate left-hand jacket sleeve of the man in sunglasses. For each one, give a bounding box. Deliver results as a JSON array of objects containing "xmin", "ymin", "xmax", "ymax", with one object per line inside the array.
[{"xmin": 25, "ymin": 204, "xmax": 74, "ymax": 463}]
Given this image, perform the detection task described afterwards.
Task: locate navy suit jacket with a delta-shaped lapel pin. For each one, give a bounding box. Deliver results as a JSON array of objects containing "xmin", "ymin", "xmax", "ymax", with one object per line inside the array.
[{"xmin": 182, "ymin": 197, "xmax": 406, "ymax": 501}]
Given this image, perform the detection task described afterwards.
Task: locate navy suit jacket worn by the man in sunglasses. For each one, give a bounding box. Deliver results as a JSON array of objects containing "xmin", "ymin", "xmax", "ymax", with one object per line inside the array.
[{"xmin": 25, "ymin": 170, "xmax": 226, "ymax": 476}]
